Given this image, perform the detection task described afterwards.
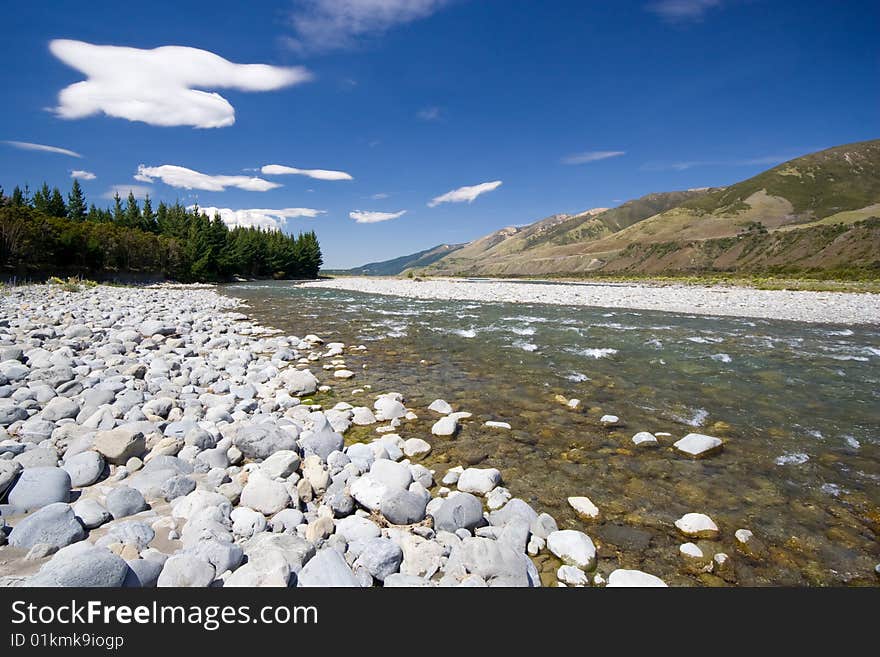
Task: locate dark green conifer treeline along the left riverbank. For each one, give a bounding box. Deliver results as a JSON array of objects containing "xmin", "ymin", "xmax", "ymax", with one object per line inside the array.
[{"xmin": 0, "ymin": 180, "xmax": 322, "ymax": 282}]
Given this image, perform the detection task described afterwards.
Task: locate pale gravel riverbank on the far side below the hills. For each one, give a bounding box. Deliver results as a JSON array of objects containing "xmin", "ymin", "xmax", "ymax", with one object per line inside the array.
[{"xmin": 306, "ymin": 277, "xmax": 880, "ymax": 324}]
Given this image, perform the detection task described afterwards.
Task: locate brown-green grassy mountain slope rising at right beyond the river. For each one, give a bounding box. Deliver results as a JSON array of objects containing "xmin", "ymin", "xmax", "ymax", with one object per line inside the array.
[{"xmin": 420, "ymin": 140, "xmax": 880, "ymax": 276}]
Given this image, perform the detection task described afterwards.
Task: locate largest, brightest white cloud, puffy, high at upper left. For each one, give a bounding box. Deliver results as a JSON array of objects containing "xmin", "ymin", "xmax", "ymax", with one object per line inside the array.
[{"xmin": 49, "ymin": 39, "xmax": 311, "ymax": 128}]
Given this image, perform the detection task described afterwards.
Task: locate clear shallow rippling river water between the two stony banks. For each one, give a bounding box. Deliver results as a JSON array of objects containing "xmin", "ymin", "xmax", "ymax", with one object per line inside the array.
[{"xmin": 222, "ymin": 282, "xmax": 880, "ymax": 585}]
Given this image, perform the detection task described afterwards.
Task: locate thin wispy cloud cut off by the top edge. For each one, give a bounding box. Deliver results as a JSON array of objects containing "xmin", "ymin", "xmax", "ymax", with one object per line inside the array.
[{"xmin": 285, "ymin": 0, "xmax": 450, "ymax": 51}]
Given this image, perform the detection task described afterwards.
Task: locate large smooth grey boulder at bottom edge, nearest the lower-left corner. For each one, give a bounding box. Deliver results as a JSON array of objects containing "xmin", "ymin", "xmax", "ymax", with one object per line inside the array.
[{"xmin": 24, "ymin": 542, "xmax": 129, "ymax": 588}]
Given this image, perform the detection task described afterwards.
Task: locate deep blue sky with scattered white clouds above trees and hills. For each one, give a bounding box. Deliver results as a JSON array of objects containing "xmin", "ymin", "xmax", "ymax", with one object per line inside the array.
[{"xmin": 0, "ymin": 0, "xmax": 880, "ymax": 268}]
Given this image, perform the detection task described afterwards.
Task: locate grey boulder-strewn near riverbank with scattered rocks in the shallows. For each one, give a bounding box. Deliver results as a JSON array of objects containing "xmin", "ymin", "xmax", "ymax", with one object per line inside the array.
[{"xmin": 0, "ymin": 286, "xmax": 696, "ymax": 587}]
